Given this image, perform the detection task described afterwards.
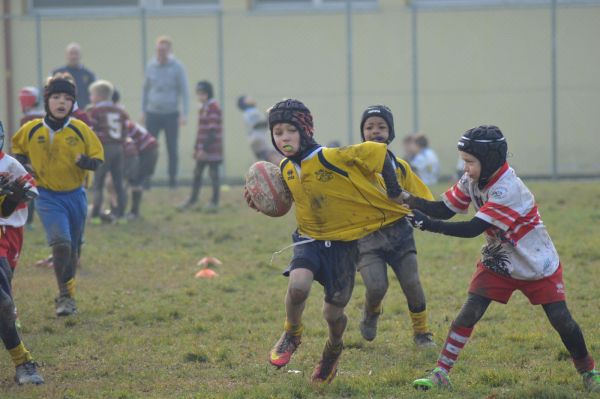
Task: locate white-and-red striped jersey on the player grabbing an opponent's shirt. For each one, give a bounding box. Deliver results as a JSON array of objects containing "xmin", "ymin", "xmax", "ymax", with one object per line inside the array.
[{"xmin": 442, "ymin": 163, "xmax": 559, "ymax": 280}]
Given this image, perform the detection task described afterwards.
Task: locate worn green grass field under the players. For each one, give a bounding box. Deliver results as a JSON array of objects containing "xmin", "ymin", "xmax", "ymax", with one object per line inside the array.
[{"xmin": 0, "ymin": 181, "xmax": 600, "ymax": 399}]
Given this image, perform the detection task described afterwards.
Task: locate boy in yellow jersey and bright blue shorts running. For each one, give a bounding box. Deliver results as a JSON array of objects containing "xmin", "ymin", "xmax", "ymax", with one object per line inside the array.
[{"xmin": 12, "ymin": 76, "xmax": 104, "ymax": 316}]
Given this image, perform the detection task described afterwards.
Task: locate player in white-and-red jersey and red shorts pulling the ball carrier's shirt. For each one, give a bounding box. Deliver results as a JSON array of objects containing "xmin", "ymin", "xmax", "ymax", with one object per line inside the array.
[{"xmin": 403, "ymin": 125, "xmax": 600, "ymax": 392}]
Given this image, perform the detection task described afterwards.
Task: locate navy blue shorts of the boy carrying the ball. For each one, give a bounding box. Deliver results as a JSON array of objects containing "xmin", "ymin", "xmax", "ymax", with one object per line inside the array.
[{"xmin": 283, "ymin": 231, "xmax": 358, "ymax": 307}]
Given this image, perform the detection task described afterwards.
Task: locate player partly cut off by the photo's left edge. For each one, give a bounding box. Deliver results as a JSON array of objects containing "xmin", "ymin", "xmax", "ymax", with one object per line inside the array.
[{"xmin": 0, "ymin": 121, "xmax": 44, "ymax": 385}]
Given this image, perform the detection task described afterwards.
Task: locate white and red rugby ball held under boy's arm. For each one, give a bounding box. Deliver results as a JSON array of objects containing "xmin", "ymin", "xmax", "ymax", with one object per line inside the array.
[{"xmin": 246, "ymin": 161, "xmax": 292, "ymax": 217}]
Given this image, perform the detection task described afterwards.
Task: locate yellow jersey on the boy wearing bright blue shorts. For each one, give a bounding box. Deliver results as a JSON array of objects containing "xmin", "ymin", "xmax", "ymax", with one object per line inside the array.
[{"xmin": 12, "ymin": 118, "xmax": 104, "ymax": 191}]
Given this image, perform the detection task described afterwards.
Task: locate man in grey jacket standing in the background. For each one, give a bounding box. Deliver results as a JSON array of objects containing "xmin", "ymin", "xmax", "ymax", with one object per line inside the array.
[{"xmin": 142, "ymin": 36, "xmax": 189, "ymax": 188}]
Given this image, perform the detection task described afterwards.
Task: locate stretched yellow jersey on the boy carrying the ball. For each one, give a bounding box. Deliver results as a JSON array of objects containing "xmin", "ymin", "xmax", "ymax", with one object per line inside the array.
[{"xmin": 280, "ymin": 142, "xmax": 409, "ymax": 241}]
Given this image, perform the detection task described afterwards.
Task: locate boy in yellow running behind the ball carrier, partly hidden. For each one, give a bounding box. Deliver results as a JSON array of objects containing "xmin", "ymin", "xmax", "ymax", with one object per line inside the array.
[{"xmin": 358, "ymin": 105, "xmax": 435, "ymax": 347}]
